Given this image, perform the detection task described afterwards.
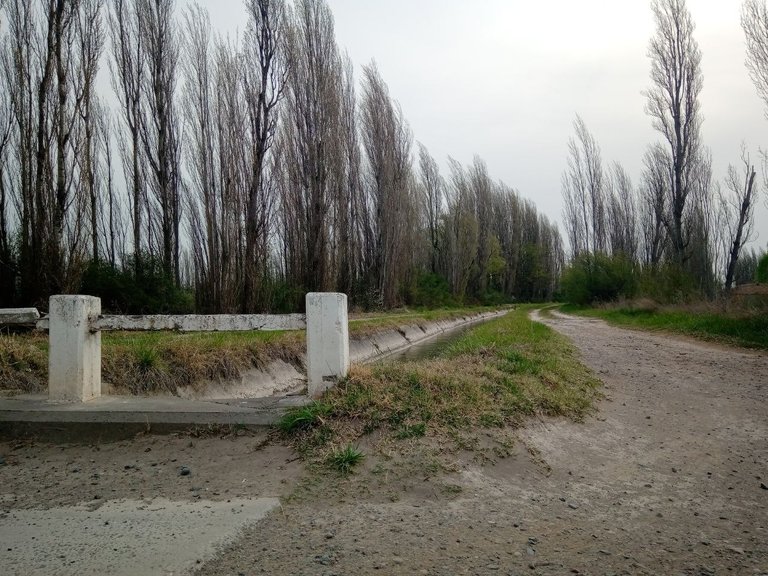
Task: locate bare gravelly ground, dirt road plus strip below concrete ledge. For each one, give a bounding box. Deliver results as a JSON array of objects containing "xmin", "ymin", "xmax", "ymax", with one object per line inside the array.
[{"xmin": 0, "ymin": 316, "xmax": 768, "ymax": 576}]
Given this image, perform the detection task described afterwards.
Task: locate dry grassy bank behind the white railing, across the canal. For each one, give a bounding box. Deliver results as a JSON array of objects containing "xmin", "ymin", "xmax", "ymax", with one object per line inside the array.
[{"xmin": 0, "ymin": 308, "xmax": 508, "ymax": 394}]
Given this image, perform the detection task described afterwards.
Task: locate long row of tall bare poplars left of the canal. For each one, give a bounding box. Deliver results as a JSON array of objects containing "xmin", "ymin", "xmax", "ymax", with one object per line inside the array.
[{"xmin": 0, "ymin": 0, "xmax": 563, "ymax": 312}]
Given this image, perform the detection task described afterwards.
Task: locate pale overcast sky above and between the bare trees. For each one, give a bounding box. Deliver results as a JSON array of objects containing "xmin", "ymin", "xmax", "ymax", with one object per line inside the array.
[{"xmin": 200, "ymin": 0, "xmax": 768, "ymax": 252}]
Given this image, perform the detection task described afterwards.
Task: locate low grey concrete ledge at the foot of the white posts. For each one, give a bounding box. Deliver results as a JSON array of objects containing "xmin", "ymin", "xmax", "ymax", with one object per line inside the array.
[{"xmin": 0, "ymin": 395, "xmax": 310, "ymax": 426}]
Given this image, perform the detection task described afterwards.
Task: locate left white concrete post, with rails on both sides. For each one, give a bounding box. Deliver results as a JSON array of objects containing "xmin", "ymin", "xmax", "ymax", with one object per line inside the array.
[{"xmin": 48, "ymin": 296, "xmax": 101, "ymax": 402}]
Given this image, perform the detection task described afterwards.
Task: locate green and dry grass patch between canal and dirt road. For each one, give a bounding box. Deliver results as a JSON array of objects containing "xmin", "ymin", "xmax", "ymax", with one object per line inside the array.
[{"xmin": 282, "ymin": 307, "xmax": 599, "ymax": 459}]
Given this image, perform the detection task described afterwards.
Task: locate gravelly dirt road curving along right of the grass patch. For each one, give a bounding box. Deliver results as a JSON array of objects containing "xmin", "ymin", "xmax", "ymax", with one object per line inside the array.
[{"xmin": 196, "ymin": 316, "xmax": 768, "ymax": 576}]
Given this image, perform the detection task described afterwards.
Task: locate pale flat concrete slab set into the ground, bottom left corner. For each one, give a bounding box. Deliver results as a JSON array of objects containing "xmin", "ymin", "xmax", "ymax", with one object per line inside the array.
[{"xmin": 0, "ymin": 498, "xmax": 280, "ymax": 576}]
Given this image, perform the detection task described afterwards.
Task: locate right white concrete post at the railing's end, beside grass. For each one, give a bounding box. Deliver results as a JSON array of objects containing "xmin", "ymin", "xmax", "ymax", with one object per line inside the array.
[{"xmin": 306, "ymin": 292, "xmax": 349, "ymax": 398}]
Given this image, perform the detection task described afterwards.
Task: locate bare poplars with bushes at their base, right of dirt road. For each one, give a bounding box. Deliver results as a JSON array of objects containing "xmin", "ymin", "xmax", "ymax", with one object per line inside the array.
[{"xmin": 562, "ymin": 0, "xmax": 768, "ymax": 303}]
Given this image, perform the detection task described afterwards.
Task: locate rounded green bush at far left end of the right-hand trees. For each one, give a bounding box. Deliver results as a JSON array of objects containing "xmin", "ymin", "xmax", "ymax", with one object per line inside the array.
[{"xmin": 561, "ymin": 252, "xmax": 637, "ymax": 306}]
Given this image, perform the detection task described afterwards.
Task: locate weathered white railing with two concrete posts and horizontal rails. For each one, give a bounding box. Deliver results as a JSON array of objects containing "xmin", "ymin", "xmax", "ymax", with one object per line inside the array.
[{"xmin": 0, "ymin": 293, "xmax": 349, "ymax": 402}]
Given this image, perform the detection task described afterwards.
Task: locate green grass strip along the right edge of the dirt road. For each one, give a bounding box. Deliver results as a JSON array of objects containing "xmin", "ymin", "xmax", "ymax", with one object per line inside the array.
[{"xmin": 563, "ymin": 305, "xmax": 768, "ymax": 350}]
